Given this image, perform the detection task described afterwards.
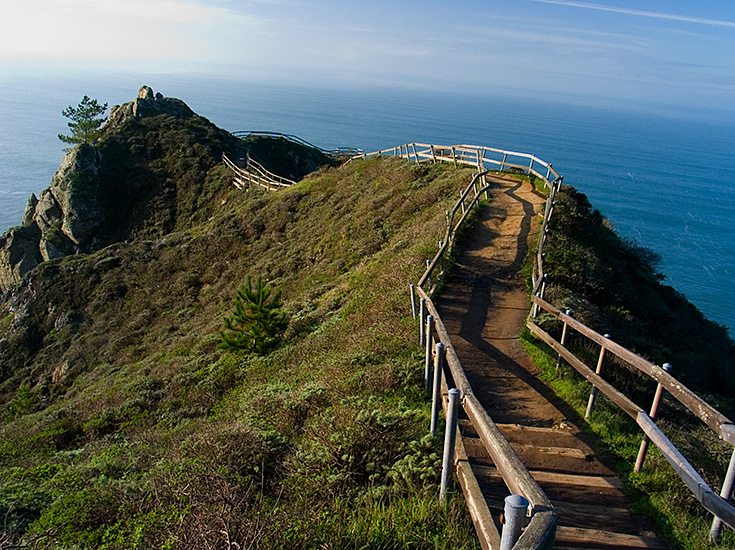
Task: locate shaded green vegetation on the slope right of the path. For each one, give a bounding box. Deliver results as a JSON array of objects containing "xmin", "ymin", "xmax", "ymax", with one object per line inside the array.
[{"xmin": 523, "ymin": 186, "xmax": 735, "ymax": 550}]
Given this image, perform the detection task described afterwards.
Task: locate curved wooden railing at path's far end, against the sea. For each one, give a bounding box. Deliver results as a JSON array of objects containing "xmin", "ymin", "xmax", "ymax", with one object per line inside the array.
[{"xmin": 353, "ymin": 143, "xmax": 559, "ymax": 187}]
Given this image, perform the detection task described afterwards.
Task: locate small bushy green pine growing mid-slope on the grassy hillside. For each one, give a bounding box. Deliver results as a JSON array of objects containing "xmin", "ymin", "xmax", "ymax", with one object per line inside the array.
[{"xmin": 220, "ymin": 276, "xmax": 288, "ymax": 353}]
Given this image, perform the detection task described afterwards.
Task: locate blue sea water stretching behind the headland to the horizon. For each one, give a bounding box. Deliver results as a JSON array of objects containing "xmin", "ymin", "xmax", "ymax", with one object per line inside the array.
[{"xmin": 0, "ymin": 74, "xmax": 735, "ymax": 334}]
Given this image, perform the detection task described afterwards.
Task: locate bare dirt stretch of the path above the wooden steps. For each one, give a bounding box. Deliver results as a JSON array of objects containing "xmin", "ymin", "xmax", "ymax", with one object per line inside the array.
[{"xmin": 439, "ymin": 172, "xmax": 565, "ymax": 427}]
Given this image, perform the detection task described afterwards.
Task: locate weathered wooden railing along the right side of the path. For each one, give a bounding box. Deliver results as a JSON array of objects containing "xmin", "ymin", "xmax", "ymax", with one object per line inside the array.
[{"xmin": 526, "ymin": 177, "xmax": 735, "ymax": 541}]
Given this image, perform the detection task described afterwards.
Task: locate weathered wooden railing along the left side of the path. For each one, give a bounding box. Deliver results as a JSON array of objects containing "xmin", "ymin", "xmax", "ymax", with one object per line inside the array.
[{"xmin": 412, "ymin": 170, "xmax": 557, "ymax": 550}]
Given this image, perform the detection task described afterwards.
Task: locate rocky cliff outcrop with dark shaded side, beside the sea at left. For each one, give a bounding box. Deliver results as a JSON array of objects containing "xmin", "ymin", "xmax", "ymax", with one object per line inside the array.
[{"xmin": 0, "ymin": 86, "xmax": 237, "ymax": 290}]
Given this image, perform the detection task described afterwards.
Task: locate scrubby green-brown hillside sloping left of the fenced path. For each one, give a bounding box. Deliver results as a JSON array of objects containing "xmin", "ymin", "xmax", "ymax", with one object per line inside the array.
[{"xmin": 0, "ymin": 159, "xmax": 476, "ymax": 548}]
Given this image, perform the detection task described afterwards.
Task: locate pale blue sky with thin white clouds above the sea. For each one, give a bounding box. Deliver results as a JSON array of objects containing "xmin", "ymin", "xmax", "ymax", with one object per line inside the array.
[{"xmin": 0, "ymin": 0, "xmax": 735, "ymax": 114}]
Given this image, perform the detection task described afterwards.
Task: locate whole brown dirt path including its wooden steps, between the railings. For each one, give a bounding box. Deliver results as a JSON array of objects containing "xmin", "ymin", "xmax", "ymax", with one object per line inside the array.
[{"xmin": 438, "ymin": 177, "xmax": 663, "ymax": 549}]
